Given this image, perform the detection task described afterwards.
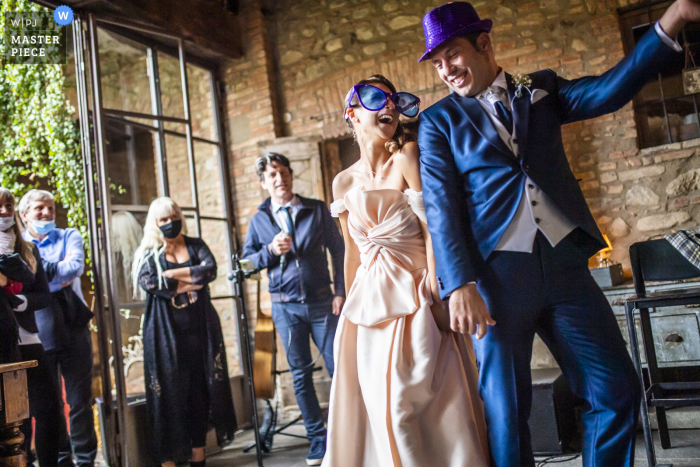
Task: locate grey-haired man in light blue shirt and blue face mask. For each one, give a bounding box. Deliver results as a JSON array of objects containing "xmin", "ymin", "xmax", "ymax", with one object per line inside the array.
[{"xmin": 19, "ymin": 190, "xmax": 97, "ymax": 467}]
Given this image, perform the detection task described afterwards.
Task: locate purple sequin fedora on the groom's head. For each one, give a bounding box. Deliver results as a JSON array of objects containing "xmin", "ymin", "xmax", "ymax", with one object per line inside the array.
[{"xmin": 418, "ymin": 2, "xmax": 493, "ymax": 62}]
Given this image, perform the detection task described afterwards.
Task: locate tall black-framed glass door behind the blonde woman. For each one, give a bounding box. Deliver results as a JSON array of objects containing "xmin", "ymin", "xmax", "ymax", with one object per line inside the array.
[{"xmin": 73, "ymin": 15, "xmax": 248, "ymax": 465}]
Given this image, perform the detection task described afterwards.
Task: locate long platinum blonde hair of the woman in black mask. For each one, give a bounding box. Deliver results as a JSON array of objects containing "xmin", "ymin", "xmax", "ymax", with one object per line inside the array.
[{"xmin": 131, "ymin": 196, "xmax": 187, "ymax": 298}]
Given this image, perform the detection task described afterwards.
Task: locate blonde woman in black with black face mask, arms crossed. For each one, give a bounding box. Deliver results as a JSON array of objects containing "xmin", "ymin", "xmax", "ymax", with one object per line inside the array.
[{"xmin": 133, "ymin": 197, "xmax": 236, "ymax": 467}]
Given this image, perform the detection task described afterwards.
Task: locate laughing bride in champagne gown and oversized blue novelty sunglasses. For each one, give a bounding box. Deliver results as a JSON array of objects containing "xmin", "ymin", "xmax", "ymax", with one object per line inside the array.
[{"xmin": 323, "ymin": 75, "xmax": 488, "ymax": 467}]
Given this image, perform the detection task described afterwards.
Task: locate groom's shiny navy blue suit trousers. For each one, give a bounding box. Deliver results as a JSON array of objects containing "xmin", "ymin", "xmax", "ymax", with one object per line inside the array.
[{"xmin": 473, "ymin": 229, "xmax": 641, "ymax": 467}]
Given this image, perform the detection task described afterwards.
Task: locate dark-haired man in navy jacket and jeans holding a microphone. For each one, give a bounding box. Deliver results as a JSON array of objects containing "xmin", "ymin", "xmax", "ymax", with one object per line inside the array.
[{"xmin": 243, "ymin": 153, "xmax": 345, "ymax": 465}]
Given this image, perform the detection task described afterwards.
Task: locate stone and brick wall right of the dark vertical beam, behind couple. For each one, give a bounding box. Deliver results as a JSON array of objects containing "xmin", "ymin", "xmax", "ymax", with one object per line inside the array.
[{"xmin": 256, "ymin": 0, "xmax": 700, "ymax": 275}]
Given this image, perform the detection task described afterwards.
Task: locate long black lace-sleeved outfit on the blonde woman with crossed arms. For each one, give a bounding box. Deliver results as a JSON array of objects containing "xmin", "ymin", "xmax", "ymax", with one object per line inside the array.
[{"xmin": 139, "ymin": 237, "xmax": 236, "ymax": 464}]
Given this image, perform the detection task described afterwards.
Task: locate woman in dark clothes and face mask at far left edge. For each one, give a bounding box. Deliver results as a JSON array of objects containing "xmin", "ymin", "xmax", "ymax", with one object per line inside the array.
[{"xmin": 0, "ymin": 187, "xmax": 63, "ymax": 466}]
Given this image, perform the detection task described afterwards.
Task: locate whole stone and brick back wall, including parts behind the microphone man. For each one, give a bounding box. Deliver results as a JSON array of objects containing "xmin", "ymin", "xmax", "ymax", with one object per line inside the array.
[{"xmin": 216, "ymin": 0, "xmax": 700, "ymax": 414}]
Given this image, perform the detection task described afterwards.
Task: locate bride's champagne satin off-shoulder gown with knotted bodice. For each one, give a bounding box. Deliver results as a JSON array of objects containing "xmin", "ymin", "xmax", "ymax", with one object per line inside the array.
[{"xmin": 323, "ymin": 186, "xmax": 488, "ymax": 467}]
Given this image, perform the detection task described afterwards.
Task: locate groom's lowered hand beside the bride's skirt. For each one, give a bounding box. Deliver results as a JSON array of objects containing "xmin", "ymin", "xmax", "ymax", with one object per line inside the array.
[{"xmin": 450, "ymin": 284, "xmax": 496, "ymax": 339}]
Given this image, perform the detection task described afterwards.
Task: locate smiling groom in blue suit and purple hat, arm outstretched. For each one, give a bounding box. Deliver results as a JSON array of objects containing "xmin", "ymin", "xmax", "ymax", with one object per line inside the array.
[{"xmin": 418, "ymin": 0, "xmax": 700, "ymax": 467}]
